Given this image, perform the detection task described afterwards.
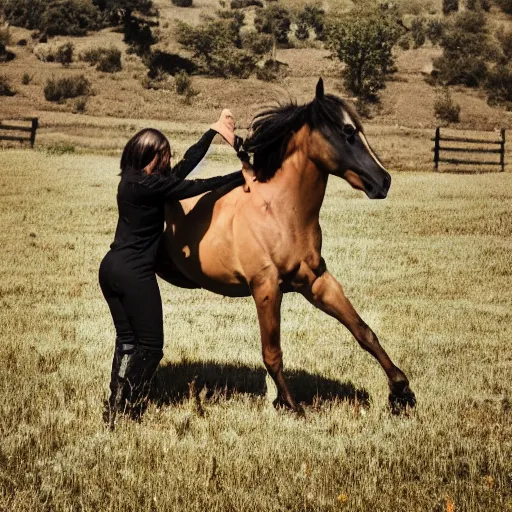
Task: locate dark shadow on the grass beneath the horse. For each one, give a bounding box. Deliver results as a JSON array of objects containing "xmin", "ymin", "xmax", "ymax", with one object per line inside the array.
[{"xmin": 151, "ymin": 361, "xmax": 370, "ymax": 406}]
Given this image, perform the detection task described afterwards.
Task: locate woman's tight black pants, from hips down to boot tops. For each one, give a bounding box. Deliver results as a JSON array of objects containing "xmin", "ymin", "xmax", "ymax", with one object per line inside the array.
[{"xmin": 99, "ymin": 251, "xmax": 164, "ymax": 353}]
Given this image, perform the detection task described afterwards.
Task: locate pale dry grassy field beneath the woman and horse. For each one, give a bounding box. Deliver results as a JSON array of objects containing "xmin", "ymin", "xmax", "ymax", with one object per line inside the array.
[{"xmin": 0, "ymin": 146, "xmax": 512, "ymax": 512}]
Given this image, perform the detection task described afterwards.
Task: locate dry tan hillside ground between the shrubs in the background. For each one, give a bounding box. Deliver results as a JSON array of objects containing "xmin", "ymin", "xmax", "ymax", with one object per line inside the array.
[{"xmin": 0, "ymin": 0, "xmax": 512, "ymax": 154}]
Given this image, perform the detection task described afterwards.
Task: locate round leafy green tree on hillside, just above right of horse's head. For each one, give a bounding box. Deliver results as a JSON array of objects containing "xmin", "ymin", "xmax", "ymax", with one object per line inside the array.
[{"xmin": 327, "ymin": 6, "xmax": 403, "ymax": 101}]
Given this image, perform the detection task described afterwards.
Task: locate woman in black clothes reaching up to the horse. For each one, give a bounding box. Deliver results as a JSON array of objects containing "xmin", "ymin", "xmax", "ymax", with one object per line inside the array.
[{"xmin": 99, "ymin": 110, "xmax": 244, "ymax": 429}]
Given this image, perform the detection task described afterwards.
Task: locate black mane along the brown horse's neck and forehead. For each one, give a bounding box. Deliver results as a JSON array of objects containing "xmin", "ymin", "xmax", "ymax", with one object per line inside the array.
[{"xmin": 244, "ymin": 94, "xmax": 363, "ymax": 181}]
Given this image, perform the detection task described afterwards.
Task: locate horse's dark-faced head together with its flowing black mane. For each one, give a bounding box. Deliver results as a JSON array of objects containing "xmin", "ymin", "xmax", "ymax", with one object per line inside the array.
[{"xmin": 244, "ymin": 79, "xmax": 391, "ymax": 199}]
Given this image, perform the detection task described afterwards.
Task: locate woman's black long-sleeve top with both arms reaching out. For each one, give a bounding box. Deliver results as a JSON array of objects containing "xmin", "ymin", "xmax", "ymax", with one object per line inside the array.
[{"xmin": 110, "ymin": 129, "xmax": 244, "ymax": 272}]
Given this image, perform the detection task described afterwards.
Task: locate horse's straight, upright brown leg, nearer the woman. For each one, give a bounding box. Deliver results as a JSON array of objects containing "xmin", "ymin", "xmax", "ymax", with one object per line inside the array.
[{"xmin": 251, "ymin": 275, "xmax": 302, "ymax": 412}]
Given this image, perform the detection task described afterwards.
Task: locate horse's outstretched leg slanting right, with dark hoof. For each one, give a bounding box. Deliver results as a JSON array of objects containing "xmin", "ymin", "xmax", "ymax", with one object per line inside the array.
[{"xmin": 297, "ymin": 271, "xmax": 416, "ymax": 414}]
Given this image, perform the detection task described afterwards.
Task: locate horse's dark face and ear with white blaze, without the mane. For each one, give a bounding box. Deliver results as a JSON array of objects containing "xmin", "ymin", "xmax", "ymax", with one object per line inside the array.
[{"xmin": 309, "ymin": 79, "xmax": 391, "ymax": 199}]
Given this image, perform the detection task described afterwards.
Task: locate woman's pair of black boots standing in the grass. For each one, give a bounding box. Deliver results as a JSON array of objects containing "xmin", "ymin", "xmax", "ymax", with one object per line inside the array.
[{"xmin": 106, "ymin": 347, "xmax": 163, "ymax": 430}]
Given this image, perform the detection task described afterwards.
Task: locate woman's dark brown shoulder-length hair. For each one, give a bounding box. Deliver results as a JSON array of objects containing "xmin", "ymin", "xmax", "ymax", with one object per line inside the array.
[{"xmin": 121, "ymin": 128, "xmax": 171, "ymax": 174}]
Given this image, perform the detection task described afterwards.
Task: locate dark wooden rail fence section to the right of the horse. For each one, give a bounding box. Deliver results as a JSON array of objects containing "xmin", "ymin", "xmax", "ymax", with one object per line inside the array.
[{"xmin": 432, "ymin": 127, "xmax": 505, "ymax": 172}]
